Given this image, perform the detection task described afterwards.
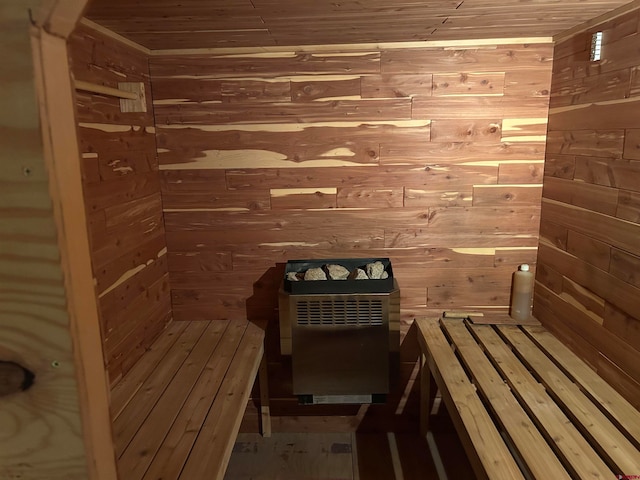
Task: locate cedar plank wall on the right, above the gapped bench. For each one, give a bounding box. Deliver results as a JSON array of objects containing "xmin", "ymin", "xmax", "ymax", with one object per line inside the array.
[{"xmin": 534, "ymin": 10, "xmax": 640, "ymax": 407}]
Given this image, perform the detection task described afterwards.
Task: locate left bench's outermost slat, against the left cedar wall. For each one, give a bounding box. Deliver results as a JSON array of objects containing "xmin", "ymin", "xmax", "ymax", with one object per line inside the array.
[{"xmin": 110, "ymin": 322, "xmax": 188, "ymax": 418}]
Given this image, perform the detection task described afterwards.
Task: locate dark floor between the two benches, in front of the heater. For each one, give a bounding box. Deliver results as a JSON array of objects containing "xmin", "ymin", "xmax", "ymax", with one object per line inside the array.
[{"xmin": 225, "ymin": 402, "xmax": 475, "ymax": 480}]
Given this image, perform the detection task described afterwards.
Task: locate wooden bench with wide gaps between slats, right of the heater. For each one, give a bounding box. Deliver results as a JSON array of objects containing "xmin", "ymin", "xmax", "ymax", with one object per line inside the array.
[{"xmin": 415, "ymin": 318, "xmax": 640, "ymax": 480}]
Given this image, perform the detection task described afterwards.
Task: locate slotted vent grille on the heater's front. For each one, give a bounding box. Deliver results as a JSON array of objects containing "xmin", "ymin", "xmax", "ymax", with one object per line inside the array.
[{"xmin": 297, "ymin": 298, "xmax": 384, "ymax": 326}]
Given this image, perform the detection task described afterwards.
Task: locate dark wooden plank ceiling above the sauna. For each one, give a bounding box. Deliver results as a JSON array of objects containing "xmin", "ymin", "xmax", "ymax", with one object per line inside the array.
[{"xmin": 86, "ymin": 0, "xmax": 629, "ymax": 50}]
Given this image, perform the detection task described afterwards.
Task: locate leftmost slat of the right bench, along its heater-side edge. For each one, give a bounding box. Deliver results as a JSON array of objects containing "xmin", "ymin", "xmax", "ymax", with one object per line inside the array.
[{"xmin": 416, "ymin": 318, "xmax": 524, "ymax": 480}]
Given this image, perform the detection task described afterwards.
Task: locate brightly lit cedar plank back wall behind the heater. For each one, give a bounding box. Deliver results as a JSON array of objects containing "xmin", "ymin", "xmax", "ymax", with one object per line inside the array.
[{"xmin": 150, "ymin": 44, "xmax": 552, "ymax": 431}]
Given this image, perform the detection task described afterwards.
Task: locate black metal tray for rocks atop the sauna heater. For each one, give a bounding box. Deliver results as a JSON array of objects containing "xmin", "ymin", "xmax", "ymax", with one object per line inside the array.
[{"xmin": 284, "ymin": 258, "xmax": 394, "ymax": 295}]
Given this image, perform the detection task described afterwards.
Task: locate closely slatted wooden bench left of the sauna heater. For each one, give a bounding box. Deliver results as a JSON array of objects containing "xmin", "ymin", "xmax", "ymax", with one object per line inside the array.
[{"xmin": 111, "ymin": 321, "xmax": 271, "ymax": 480}]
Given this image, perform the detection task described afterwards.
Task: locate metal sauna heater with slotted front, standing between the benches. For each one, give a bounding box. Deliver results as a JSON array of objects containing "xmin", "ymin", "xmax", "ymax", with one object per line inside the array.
[{"xmin": 279, "ymin": 259, "xmax": 400, "ymax": 404}]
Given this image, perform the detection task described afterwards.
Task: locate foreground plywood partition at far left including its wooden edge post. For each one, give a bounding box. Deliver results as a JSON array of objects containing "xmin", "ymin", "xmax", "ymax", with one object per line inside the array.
[{"xmin": 0, "ymin": 0, "xmax": 117, "ymax": 480}]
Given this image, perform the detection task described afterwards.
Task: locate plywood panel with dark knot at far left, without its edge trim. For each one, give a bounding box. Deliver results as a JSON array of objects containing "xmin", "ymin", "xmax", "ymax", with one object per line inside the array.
[{"xmin": 0, "ymin": 10, "xmax": 88, "ymax": 479}]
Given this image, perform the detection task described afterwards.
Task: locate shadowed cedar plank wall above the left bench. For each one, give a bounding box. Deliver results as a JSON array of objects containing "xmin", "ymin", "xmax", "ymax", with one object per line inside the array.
[{"xmin": 70, "ymin": 26, "xmax": 171, "ymax": 385}]
